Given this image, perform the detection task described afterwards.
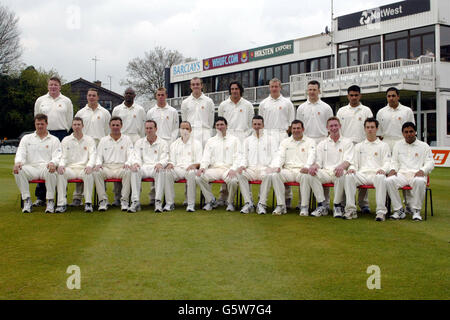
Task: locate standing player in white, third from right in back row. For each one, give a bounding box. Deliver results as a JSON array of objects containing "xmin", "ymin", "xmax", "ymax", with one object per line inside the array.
[{"xmin": 296, "ymin": 80, "xmax": 333, "ymax": 144}]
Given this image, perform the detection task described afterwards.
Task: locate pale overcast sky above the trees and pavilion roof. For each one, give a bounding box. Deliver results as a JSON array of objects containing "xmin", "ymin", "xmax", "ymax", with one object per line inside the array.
[{"xmin": 0, "ymin": 0, "xmax": 397, "ymax": 93}]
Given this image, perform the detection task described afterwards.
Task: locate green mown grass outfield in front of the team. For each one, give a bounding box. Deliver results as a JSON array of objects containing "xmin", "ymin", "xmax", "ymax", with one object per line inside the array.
[{"xmin": 0, "ymin": 155, "xmax": 450, "ymax": 300}]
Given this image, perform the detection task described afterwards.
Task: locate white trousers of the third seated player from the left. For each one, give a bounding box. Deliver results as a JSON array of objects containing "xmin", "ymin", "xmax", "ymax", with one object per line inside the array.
[{"xmin": 94, "ymin": 164, "xmax": 131, "ymax": 202}]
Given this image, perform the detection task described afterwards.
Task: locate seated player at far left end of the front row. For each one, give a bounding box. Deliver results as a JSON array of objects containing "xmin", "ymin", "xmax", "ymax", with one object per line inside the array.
[{"xmin": 13, "ymin": 114, "xmax": 61, "ymax": 213}]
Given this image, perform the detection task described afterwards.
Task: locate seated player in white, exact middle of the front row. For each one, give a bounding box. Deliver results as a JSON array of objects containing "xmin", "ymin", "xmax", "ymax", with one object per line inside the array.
[{"xmin": 195, "ymin": 117, "xmax": 242, "ymax": 211}]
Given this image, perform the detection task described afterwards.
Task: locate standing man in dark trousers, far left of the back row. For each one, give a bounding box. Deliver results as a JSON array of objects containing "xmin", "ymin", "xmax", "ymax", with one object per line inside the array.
[{"xmin": 34, "ymin": 77, "xmax": 73, "ymax": 206}]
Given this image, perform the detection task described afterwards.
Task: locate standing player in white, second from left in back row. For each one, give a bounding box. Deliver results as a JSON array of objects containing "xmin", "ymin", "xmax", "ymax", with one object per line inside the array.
[{"xmin": 74, "ymin": 88, "xmax": 112, "ymax": 207}]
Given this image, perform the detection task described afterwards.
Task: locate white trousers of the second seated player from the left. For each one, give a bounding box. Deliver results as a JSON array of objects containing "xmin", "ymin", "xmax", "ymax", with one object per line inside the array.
[{"xmin": 56, "ymin": 167, "xmax": 94, "ymax": 206}]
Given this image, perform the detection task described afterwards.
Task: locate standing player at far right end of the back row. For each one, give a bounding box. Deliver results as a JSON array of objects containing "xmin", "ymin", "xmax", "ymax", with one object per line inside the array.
[{"xmin": 377, "ymin": 87, "xmax": 415, "ymax": 151}]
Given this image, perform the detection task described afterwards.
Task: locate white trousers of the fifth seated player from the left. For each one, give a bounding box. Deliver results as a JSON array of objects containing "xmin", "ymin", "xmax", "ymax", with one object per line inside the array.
[{"xmin": 164, "ymin": 167, "xmax": 197, "ymax": 205}]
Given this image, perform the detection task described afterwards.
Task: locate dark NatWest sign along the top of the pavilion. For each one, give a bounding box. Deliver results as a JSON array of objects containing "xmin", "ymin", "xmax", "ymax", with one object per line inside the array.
[{"xmin": 337, "ymin": 0, "xmax": 430, "ymax": 30}]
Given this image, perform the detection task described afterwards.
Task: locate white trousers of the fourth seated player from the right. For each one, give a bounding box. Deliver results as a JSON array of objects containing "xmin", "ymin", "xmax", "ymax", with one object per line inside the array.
[{"xmin": 271, "ymin": 169, "xmax": 310, "ymax": 207}]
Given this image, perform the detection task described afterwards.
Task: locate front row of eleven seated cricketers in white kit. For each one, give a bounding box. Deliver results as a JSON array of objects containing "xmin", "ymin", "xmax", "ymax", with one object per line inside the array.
[{"xmin": 14, "ymin": 114, "xmax": 434, "ymax": 221}]
